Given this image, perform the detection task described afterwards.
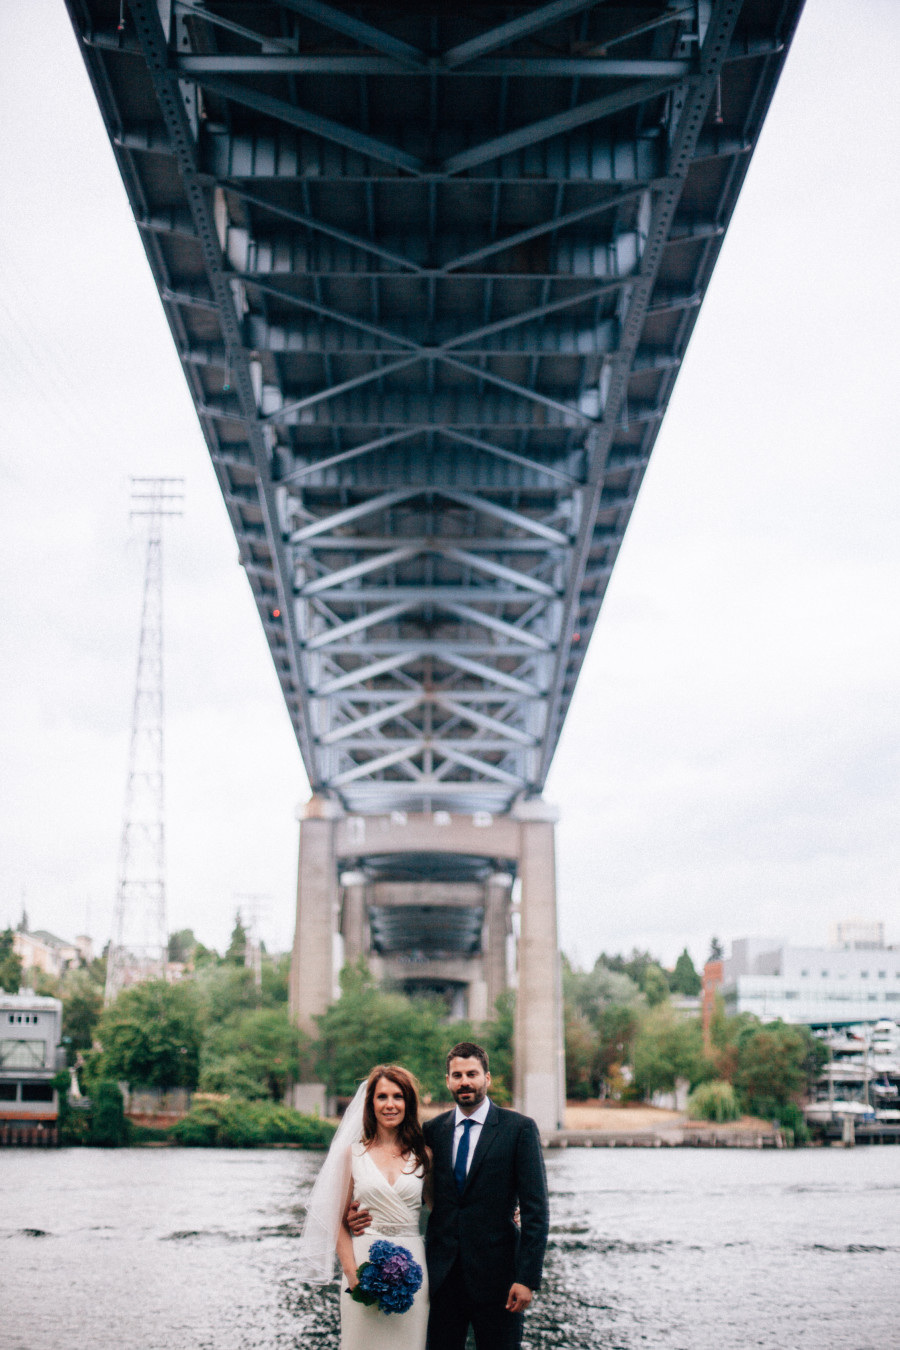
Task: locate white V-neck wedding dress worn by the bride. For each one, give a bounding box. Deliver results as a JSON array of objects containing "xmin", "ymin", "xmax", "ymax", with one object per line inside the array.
[{"xmin": 340, "ymin": 1143, "xmax": 428, "ymax": 1350}]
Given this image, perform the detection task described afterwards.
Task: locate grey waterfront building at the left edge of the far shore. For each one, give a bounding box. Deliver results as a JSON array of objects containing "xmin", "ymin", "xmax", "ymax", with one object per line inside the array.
[{"xmin": 0, "ymin": 990, "xmax": 66, "ymax": 1133}]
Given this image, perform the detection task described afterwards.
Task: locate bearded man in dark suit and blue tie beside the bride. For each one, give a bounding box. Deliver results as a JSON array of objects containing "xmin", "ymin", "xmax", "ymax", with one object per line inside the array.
[{"xmin": 348, "ymin": 1041, "xmax": 549, "ymax": 1350}]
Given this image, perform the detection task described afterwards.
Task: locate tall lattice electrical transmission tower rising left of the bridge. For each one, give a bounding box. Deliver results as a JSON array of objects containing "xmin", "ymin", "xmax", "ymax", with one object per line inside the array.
[{"xmin": 107, "ymin": 478, "xmax": 185, "ymax": 1002}]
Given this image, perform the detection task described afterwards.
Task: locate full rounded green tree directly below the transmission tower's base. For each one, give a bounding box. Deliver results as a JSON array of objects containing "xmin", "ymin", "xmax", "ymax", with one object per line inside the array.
[{"xmin": 97, "ymin": 980, "xmax": 201, "ymax": 1088}]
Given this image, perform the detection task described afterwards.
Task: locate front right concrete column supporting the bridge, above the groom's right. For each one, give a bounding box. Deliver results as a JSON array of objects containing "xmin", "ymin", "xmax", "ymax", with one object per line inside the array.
[{"xmin": 513, "ymin": 799, "xmax": 565, "ymax": 1130}]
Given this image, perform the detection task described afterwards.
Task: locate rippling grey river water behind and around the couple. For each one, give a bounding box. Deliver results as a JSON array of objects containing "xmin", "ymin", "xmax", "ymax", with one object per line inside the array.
[{"xmin": 0, "ymin": 1148, "xmax": 900, "ymax": 1350}]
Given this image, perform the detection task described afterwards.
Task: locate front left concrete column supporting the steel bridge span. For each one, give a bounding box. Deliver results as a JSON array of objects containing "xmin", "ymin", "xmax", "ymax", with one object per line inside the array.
[{"xmin": 289, "ymin": 798, "xmax": 337, "ymax": 1115}]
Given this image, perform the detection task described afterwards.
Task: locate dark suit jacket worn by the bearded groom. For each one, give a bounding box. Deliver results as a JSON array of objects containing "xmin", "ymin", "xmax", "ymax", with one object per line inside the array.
[{"xmin": 425, "ymin": 1103, "xmax": 549, "ymax": 1301}]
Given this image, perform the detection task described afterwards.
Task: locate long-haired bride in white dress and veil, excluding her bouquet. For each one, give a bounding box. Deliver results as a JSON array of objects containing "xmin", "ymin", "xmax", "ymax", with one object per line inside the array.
[{"xmin": 301, "ymin": 1064, "xmax": 430, "ymax": 1350}]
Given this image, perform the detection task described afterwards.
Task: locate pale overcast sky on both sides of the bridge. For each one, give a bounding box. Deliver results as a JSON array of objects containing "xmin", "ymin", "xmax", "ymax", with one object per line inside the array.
[{"xmin": 0, "ymin": 0, "xmax": 900, "ymax": 964}]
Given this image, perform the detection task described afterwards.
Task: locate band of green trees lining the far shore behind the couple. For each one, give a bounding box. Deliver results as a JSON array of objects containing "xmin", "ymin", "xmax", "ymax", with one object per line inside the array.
[{"xmin": 0, "ymin": 918, "xmax": 819, "ymax": 1143}]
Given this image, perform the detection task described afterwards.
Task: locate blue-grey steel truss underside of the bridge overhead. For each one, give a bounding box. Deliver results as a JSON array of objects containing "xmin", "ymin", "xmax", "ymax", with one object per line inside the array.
[{"xmin": 67, "ymin": 0, "xmax": 801, "ymax": 811}]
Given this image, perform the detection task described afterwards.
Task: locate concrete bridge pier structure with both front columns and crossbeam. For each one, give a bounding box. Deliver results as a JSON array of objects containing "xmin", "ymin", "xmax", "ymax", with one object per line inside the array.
[{"xmin": 290, "ymin": 798, "xmax": 564, "ymax": 1130}]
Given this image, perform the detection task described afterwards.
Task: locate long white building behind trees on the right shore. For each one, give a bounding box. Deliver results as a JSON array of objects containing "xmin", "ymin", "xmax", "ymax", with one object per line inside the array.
[{"xmin": 722, "ymin": 938, "xmax": 900, "ymax": 1026}]
